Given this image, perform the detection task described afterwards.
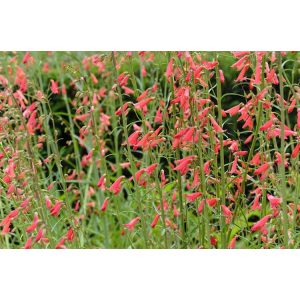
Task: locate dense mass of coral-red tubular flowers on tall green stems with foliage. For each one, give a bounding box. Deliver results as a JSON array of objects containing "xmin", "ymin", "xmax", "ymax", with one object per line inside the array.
[{"xmin": 0, "ymin": 52, "xmax": 300, "ymax": 248}]
